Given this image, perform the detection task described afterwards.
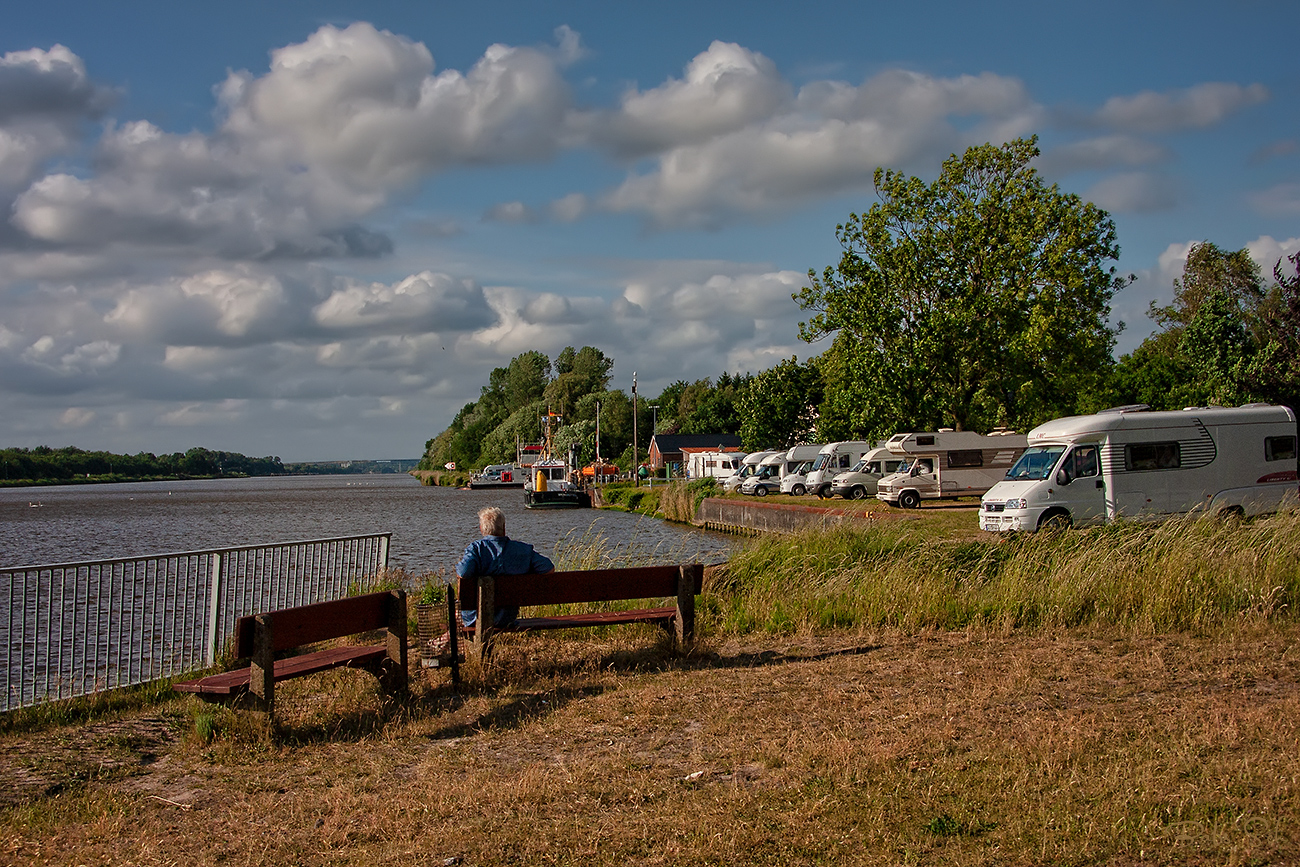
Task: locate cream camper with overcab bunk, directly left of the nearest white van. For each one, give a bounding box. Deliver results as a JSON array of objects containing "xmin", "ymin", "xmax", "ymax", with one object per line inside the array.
[{"xmin": 876, "ymin": 429, "xmax": 1028, "ymax": 508}]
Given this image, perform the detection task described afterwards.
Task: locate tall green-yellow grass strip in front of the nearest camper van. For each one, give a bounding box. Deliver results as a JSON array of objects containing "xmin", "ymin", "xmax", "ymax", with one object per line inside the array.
[{"xmin": 705, "ymin": 513, "xmax": 1300, "ymax": 634}]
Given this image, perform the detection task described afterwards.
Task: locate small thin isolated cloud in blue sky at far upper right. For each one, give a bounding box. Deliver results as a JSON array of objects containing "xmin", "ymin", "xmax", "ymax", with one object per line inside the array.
[{"xmin": 1095, "ymin": 82, "xmax": 1269, "ymax": 133}]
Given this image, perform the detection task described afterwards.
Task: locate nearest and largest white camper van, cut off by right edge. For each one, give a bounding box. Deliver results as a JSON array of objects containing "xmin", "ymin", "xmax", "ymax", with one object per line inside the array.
[{"xmin": 979, "ymin": 404, "xmax": 1297, "ymax": 532}]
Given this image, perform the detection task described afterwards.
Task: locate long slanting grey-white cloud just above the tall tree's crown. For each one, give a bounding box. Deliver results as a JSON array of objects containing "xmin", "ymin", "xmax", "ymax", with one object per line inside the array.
[{"xmin": 599, "ymin": 71, "xmax": 1040, "ymax": 227}]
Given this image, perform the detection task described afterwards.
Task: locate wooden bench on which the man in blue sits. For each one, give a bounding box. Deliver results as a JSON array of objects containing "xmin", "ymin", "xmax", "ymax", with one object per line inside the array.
[{"xmin": 460, "ymin": 563, "xmax": 705, "ymax": 659}]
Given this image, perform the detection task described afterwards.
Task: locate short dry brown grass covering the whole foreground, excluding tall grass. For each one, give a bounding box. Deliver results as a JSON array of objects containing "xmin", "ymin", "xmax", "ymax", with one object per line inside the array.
[{"xmin": 0, "ymin": 625, "xmax": 1300, "ymax": 864}]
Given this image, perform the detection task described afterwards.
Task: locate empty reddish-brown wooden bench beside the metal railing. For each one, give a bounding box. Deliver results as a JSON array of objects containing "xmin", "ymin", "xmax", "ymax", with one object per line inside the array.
[{"xmin": 176, "ymin": 590, "xmax": 407, "ymax": 714}]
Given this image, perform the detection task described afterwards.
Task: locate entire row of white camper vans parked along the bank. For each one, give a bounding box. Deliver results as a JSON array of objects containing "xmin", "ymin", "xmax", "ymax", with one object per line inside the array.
[{"xmin": 712, "ymin": 404, "xmax": 1300, "ymax": 532}]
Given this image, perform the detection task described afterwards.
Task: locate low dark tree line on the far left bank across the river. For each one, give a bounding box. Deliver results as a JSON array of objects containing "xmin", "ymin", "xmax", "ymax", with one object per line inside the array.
[{"xmin": 0, "ymin": 446, "xmax": 287, "ymax": 485}]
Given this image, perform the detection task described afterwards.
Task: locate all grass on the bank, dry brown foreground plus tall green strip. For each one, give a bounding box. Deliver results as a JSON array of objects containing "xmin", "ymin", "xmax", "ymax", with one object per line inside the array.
[{"xmin": 0, "ymin": 510, "xmax": 1300, "ymax": 866}]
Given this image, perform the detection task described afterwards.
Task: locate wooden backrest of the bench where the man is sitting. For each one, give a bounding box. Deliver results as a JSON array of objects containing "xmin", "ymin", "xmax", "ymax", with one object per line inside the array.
[{"xmin": 460, "ymin": 565, "xmax": 705, "ymax": 607}]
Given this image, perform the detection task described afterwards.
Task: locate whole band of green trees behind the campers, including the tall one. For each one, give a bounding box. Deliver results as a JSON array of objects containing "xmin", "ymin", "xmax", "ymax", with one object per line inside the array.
[{"xmin": 421, "ymin": 138, "xmax": 1300, "ymax": 469}]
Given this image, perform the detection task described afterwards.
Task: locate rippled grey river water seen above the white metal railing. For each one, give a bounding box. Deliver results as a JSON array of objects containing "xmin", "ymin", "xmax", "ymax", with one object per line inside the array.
[{"xmin": 0, "ymin": 474, "xmax": 732, "ymax": 575}]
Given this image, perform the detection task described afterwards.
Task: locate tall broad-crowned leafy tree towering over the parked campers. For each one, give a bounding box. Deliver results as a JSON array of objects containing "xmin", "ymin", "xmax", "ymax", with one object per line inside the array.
[{"xmin": 794, "ymin": 138, "xmax": 1126, "ymax": 437}]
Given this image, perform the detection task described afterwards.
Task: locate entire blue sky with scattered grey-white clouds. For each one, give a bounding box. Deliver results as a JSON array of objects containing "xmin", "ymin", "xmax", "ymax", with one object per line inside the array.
[{"xmin": 0, "ymin": 0, "xmax": 1300, "ymax": 461}]
